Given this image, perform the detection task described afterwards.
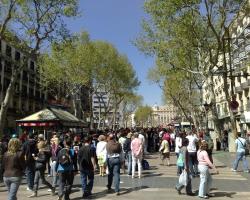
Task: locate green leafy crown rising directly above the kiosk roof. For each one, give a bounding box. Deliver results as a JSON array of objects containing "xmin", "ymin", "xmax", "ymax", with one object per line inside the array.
[{"xmin": 38, "ymin": 32, "xmax": 96, "ymax": 95}]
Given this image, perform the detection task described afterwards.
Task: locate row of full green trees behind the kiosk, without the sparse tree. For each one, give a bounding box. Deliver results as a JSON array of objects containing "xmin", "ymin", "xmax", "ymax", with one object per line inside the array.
[{"xmin": 39, "ymin": 32, "xmax": 141, "ymax": 128}]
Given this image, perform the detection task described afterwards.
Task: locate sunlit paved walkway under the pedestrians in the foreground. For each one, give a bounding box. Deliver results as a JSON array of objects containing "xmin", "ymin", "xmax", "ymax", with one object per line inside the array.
[{"xmin": 0, "ymin": 153, "xmax": 250, "ymax": 200}]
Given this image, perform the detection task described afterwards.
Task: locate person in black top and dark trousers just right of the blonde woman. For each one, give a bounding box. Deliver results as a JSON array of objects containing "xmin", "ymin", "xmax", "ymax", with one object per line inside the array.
[{"xmin": 23, "ymin": 133, "xmax": 38, "ymax": 191}]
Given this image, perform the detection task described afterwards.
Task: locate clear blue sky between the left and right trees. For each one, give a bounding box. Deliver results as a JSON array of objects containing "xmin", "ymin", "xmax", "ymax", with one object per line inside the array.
[{"xmin": 67, "ymin": 0, "xmax": 162, "ymax": 105}]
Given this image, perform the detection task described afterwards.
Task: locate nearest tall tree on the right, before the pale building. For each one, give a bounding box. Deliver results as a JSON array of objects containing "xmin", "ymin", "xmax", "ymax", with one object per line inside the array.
[{"xmin": 136, "ymin": 0, "xmax": 244, "ymax": 150}]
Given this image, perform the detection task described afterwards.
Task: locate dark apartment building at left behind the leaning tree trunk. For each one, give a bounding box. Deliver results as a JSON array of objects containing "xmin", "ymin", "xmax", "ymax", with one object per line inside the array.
[{"xmin": 0, "ymin": 41, "xmax": 47, "ymax": 131}]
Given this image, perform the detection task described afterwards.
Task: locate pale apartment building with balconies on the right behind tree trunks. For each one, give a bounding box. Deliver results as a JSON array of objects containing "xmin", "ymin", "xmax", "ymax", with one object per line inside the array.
[{"xmin": 203, "ymin": 1, "xmax": 250, "ymax": 151}]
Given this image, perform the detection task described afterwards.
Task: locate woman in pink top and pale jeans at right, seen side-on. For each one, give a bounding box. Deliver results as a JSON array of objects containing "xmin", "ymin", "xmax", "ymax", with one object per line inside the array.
[{"xmin": 197, "ymin": 140, "xmax": 219, "ymax": 199}]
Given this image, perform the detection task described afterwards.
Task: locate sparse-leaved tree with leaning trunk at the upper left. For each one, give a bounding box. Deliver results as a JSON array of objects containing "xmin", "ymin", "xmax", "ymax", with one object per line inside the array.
[{"xmin": 0, "ymin": 0, "xmax": 78, "ymax": 137}]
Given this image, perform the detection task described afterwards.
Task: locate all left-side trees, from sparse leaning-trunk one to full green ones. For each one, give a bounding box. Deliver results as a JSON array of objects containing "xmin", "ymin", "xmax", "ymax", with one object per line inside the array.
[{"xmin": 0, "ymin": 0, "xmax": 139, "ymax": 134}]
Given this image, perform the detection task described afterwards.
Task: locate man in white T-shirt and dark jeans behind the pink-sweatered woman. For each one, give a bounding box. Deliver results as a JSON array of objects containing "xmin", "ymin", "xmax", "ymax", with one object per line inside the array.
[{"xmin": 186, "ymin": 131, "xmax": 198, "ymax": 177}]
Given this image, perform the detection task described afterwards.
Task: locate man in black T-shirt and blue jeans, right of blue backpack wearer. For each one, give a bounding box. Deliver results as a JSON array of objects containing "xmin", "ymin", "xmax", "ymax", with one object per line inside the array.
[{"xmin": 78, "ymin": 136, "xmax": 96, "ymax": 198}]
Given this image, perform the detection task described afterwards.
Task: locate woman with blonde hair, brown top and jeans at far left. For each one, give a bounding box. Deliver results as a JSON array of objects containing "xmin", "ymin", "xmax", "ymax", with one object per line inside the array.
[{"xmin": 3, "ymin": 138, "xmax": 25, "ymax": 200}]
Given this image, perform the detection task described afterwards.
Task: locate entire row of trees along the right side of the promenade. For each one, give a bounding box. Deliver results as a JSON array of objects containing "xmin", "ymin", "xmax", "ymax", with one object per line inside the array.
[{"xmin": 135, "ymin": 0, "xmax": 249, "ymax": 147}]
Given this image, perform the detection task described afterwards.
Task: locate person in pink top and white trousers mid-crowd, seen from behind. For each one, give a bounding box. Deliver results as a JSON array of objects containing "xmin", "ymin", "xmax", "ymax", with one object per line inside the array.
[{"xmin": 131, "ymin": 132, "xmax": 143, "ymax": 178}]
